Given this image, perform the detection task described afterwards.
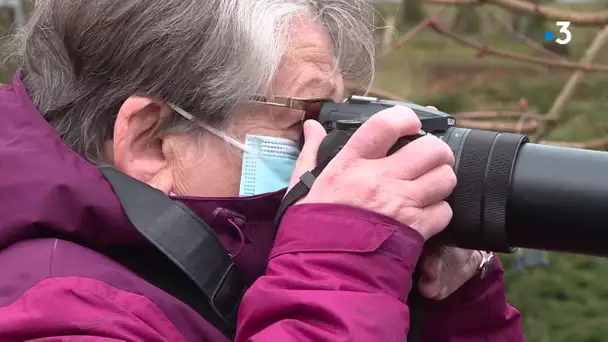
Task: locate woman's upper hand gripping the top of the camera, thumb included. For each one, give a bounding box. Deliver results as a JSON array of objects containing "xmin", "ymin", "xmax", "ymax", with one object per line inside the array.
[{"xmin": 291, "ymin": 106, "xmax": 456, "ymax": 240}]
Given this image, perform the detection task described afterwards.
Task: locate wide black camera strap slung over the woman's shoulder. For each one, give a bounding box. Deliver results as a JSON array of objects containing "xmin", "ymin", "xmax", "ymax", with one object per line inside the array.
[{"xmin": 98, "ymin": 167, "xmax": 246, "ymax": 337}]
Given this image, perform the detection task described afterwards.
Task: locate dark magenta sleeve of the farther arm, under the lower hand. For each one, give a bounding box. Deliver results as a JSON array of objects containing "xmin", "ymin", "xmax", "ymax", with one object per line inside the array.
[{"xmin": 422, "ymin": 259, "xmax": 524, "ymax": 342}]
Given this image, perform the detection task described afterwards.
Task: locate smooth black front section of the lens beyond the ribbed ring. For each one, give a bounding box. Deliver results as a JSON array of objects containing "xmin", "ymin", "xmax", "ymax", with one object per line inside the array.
[{"xmin": 506, "ymin": 144, "xmax": 608, "ymax": 256}]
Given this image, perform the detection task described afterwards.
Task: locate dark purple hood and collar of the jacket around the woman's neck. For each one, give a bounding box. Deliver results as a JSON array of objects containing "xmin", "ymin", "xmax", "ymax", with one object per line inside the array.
[{"xmin": 0, "ymin": 71, "xmax": 283, "ymax": 282}]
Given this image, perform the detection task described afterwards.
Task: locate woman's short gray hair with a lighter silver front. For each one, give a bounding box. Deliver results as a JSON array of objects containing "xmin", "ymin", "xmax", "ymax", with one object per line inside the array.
[{"xmin": 10, "ymin": 0, "xmax": 375, "ymax": 163}]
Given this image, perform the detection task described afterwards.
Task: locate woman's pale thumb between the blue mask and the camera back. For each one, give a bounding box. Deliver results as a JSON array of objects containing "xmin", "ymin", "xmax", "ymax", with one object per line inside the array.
[{"xmin": 289, "ymin": 120, "xmax": 327, "ymax": 189}]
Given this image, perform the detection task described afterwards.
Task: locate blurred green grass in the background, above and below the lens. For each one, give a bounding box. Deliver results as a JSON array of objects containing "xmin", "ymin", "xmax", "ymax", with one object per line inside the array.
[{"xmin": 0, "ymin": 1, "xmax": 608, "ymax": 342}]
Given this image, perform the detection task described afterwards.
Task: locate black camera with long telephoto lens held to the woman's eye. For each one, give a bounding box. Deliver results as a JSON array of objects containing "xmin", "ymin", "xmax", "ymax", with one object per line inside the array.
[{"xmin": 318, "ymin": 96, "xmax": 608, "ymax": 256}]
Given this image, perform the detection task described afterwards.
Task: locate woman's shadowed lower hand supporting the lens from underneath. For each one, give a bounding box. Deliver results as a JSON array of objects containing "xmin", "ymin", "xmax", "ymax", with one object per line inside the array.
[{"xmin": 418, "ymin": 247, "xmax": 483, "ymax": 300}]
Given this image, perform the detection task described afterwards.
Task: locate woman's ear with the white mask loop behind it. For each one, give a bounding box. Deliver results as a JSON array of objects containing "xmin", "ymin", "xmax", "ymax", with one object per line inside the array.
[{"xmin": 110, "ymin": 96, "xmax": 173, "ymax": 193}]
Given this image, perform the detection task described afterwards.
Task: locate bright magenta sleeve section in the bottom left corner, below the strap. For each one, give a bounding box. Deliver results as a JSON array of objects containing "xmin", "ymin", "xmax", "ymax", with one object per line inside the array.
[{"xmin": 0, "ymin": 277, "xmax": 185, "ymax": 342}]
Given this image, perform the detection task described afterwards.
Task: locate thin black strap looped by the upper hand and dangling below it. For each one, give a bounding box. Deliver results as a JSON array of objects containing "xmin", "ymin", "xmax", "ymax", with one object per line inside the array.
[{"xmin": 274, "ymin": 131, "xmax": 424, "ymax": 342}]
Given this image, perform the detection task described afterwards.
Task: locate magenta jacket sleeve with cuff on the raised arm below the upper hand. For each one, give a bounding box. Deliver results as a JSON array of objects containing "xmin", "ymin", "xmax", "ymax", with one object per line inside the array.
[{"xmin": 236, "ymin": 204, "xmax": 424, "ymax": 342}]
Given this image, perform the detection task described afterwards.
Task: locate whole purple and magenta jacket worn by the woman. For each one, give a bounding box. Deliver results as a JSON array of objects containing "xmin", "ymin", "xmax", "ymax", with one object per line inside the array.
[{"xmin": 0, "ymin": 73, "xmax": 523, "ymax": 342}]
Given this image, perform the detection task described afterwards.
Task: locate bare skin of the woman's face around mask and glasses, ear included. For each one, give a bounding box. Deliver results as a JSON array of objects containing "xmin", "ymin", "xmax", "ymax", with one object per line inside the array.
[{"xmin": 106, "ymin": 16, "xmax": 344, "ymax": 197}]
